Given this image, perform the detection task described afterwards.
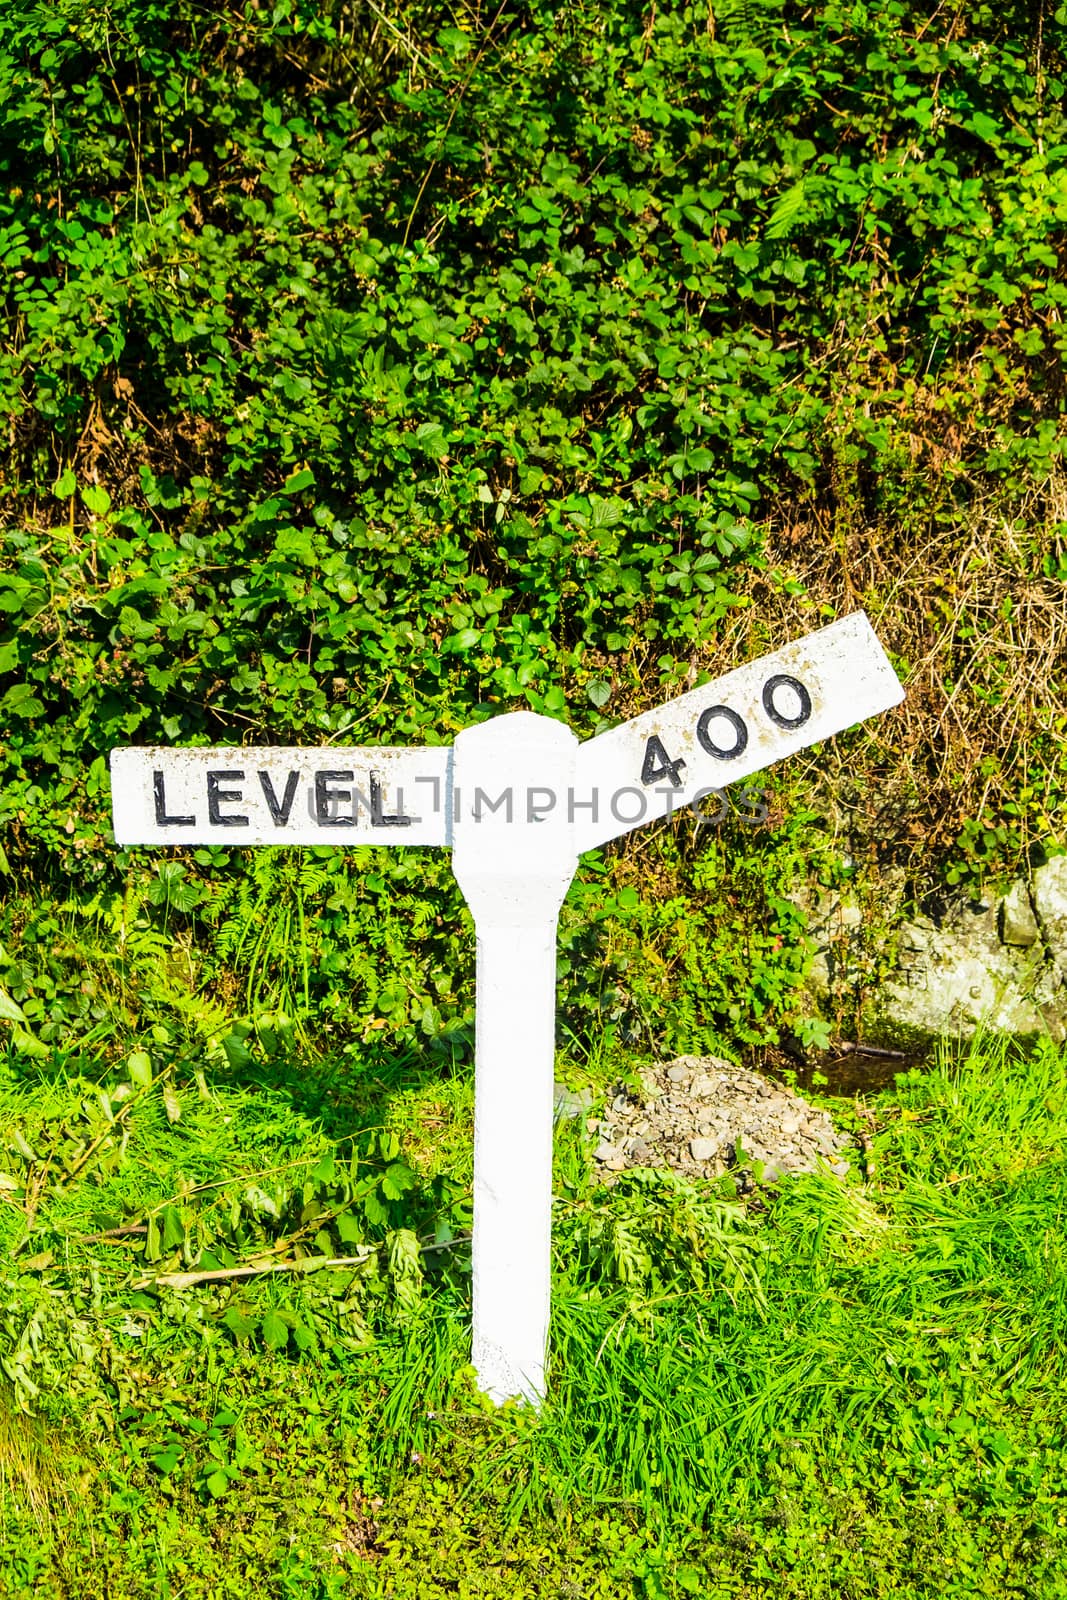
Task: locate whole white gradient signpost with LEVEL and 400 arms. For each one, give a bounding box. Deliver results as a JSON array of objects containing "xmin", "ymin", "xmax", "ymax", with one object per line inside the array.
[{"xmin": 110, "ymin": 611, "xmax": 904, "ymax": 1403}]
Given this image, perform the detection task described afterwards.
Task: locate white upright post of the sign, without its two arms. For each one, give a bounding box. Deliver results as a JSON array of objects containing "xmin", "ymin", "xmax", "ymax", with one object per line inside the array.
[{"xmin": 453, "ymin": 712, "xmax": 577, "ymax": 1403}]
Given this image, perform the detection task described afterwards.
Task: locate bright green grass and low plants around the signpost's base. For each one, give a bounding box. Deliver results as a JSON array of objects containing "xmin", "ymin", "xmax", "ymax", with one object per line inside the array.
[{"xmin": 0, "ymin": 1043, "xmax": 1067, "ymax": 1600}]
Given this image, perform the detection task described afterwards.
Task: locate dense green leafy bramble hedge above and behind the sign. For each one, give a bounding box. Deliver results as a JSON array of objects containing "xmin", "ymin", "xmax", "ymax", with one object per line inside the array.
[{"xmin": 0, "ymin": 0, "xmax": 1067, "ymax": 1049}]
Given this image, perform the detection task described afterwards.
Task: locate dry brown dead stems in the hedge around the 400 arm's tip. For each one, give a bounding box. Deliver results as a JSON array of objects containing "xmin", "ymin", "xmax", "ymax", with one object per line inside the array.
[{"xmin": 717, "ymin": 477, "xmax": 1067, "ymax": 874}]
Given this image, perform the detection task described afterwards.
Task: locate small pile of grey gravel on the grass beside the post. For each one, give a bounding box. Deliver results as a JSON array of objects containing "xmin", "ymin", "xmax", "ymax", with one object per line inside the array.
[{"xmin": 557, "ymin": 1056, "xmax": 848, "ymax": 1182}]
